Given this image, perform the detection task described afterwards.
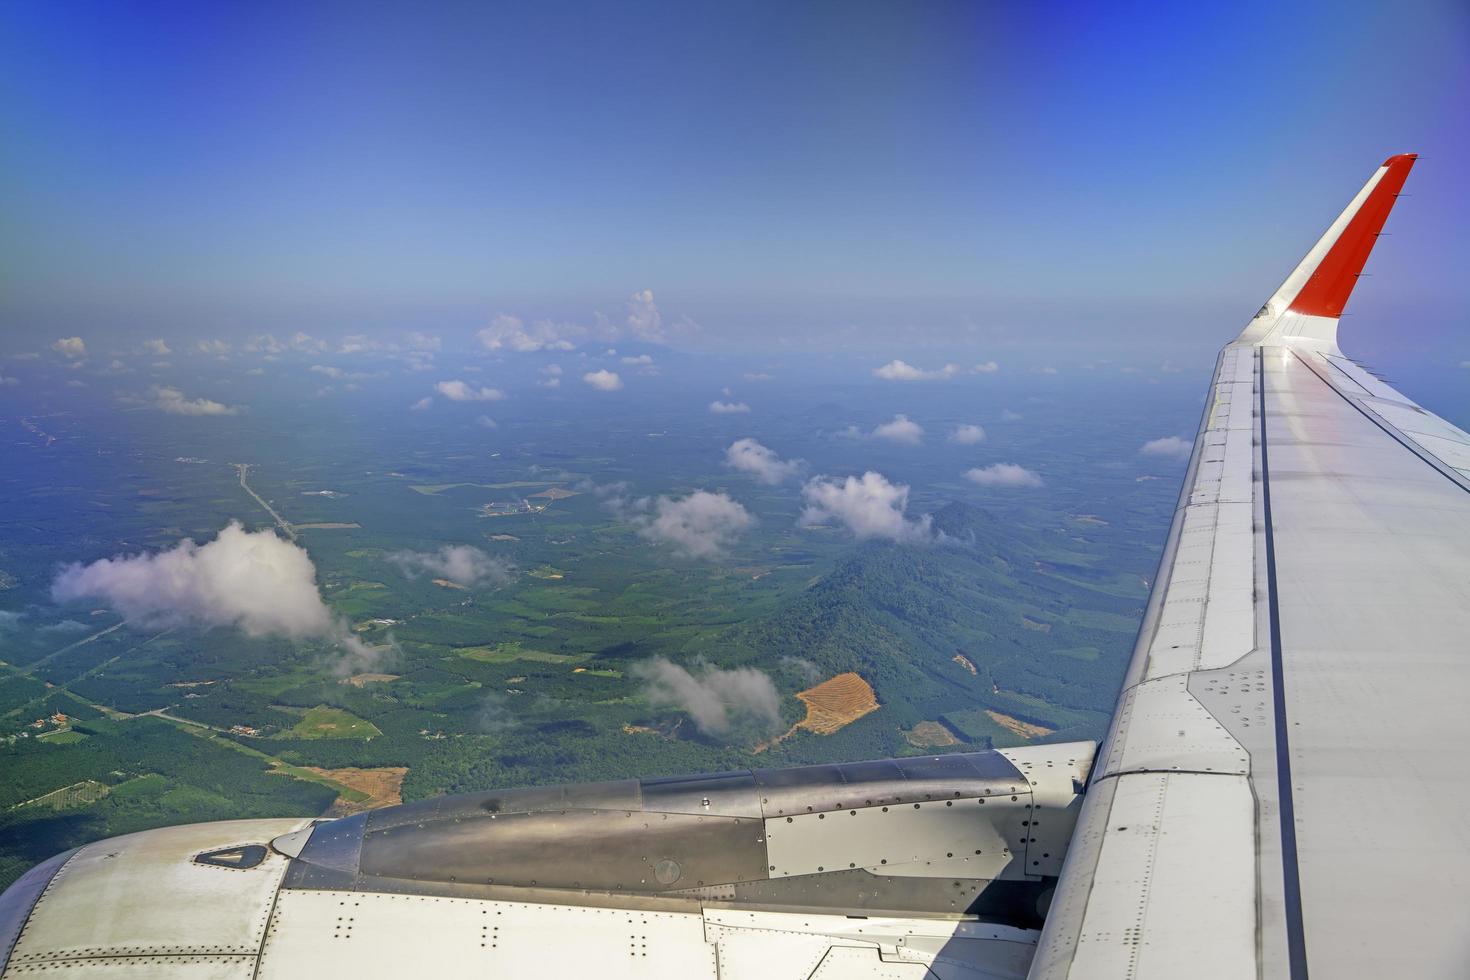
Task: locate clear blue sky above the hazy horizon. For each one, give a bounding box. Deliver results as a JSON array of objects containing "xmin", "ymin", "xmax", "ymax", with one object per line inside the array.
[{"xmin": 0, "ymin": 0, "xmax": 1470, "ymax": 360}]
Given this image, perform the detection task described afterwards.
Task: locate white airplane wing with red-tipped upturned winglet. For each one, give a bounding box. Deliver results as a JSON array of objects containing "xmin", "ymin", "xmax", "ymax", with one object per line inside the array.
[{"xmin": 1030, "ymin": 154, "xmax": 1470, "ymax": 980}]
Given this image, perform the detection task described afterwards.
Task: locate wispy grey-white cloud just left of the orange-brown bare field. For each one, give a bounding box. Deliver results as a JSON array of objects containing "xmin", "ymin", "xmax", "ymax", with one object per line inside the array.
[{"xmin": 629, "ymin": 657, "xmax": 781, "ymax": 736}]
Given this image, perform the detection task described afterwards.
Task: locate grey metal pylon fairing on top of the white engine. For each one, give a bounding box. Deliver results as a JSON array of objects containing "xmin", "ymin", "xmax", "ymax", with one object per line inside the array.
[{"xmin": 278, "ymin": 743, "xmax": 1095, "ymax": 926}]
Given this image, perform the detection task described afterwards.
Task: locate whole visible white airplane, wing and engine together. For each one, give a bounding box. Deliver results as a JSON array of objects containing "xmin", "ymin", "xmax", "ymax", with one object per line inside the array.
[{"xmin": 0, "ymin": 156, "xmax": 1452, "ymax": 980}]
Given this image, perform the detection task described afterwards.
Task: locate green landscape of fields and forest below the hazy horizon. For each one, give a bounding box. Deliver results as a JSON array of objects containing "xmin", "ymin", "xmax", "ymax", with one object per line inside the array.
[{"xmin": 0, "ymin": 358, "xmax": 1193, "ymax": 884}]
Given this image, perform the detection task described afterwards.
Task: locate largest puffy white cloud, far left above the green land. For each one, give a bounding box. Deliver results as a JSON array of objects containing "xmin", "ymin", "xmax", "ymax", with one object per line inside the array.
[{"xmin": 51, "ymin": 520, "xmax": 370, "ymax": 655}]
